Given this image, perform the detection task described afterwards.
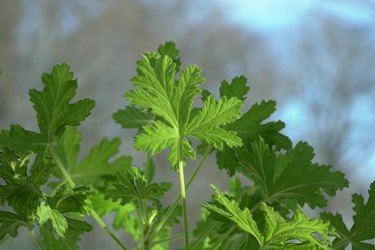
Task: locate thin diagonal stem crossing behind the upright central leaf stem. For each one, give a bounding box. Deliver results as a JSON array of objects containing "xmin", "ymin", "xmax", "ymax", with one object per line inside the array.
[{"xmin": 148, "ymin": 146, "xmax": 212, "ymax": 243}]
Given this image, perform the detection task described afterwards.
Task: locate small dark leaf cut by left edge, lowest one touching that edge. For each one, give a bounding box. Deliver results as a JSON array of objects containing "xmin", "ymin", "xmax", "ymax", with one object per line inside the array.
[{"xmin": 0, "ymin": 211, "xmax": 27, "ymax": 242}]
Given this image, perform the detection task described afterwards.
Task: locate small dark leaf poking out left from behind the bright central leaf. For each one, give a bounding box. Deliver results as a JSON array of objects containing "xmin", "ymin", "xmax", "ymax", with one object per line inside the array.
[{"xmin": 113, "ymin": 106, "xmax": 154, "ymax": 129}]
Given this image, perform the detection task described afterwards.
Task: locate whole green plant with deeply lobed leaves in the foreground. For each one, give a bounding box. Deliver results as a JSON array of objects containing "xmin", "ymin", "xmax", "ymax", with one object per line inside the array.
[{"xmin": 0, "ymin": 42, "xmax": 375, "ymax": 249}]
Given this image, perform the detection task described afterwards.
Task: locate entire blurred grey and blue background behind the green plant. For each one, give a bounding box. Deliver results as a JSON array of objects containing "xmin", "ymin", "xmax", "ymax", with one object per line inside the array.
[{"xmin": 0, "ymin": 0, "xmax": 375, "ymax": 249}]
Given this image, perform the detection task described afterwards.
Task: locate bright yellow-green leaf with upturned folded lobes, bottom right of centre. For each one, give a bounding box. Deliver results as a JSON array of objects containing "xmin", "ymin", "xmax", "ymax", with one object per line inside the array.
[{"xmin": 204, "ymin": 186, "xmax": 336, "ymax": 249}]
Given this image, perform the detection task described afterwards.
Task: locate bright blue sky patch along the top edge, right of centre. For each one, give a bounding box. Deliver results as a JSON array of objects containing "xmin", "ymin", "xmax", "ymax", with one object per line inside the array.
[{"xmin": 220, "ymin": 0, "xmax": 375, "ymax": 32}]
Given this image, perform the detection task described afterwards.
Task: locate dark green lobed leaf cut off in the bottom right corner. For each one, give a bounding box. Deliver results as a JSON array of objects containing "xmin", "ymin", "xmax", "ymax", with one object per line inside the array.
[{"xmin": 321, "ymin": 182, "xmax": 375, "ymax": 250}]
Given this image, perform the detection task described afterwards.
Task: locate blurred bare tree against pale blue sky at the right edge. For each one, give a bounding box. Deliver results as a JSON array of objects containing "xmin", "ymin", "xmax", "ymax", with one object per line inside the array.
[{"xmin": 295, "ymin": 12, "xmax": 375, "ymax": 178}]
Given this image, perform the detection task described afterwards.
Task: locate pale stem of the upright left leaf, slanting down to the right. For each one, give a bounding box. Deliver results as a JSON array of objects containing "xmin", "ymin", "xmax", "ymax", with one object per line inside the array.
[{"xmin": 48, "ymin": 144, "xmax": 128, "ymax": 250}]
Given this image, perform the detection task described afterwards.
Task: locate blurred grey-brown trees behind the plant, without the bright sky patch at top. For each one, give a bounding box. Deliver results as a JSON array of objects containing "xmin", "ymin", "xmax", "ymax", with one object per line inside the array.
[{"xmin": 0, "ymin": 0, "xmax": 375, "ymax": 249}]
